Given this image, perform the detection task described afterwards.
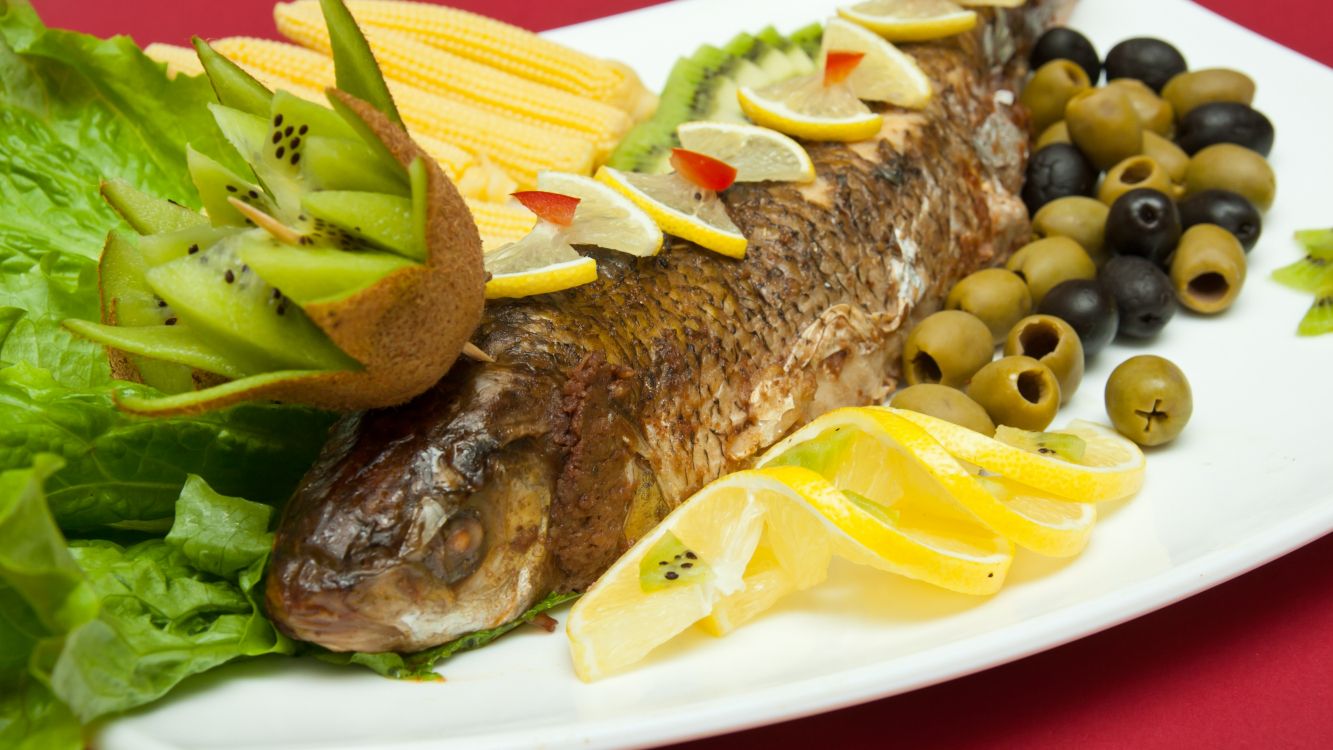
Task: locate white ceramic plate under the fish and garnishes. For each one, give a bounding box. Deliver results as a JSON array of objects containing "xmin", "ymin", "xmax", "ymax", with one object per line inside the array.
[{"xmin": 99, "ymin": 0, "xmax": 1333, "ymax": 750}]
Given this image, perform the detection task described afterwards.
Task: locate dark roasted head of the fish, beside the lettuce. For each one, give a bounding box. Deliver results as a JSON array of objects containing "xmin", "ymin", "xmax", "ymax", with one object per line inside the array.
[{"xmin": 265, "ymin": 366, "xmax": 559, "ymax": 651}]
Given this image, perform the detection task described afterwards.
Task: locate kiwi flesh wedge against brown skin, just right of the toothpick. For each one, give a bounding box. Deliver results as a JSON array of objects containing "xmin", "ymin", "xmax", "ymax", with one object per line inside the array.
[{"xmin": 301, "ymin": 190, "xmax": 425, "ymax": 260}]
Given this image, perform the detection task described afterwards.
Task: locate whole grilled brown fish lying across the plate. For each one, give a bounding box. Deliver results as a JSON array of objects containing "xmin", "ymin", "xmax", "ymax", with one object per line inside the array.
[{"xmin": 267, "ymin": 0, "xmax": 1072, "ymax": 651}]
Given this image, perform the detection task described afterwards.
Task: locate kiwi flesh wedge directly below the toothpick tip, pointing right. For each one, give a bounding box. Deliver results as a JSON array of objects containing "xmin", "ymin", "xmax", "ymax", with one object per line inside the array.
[{"xmin": 236, "ymin": 236, "xmax": 413, "ymax": 305}]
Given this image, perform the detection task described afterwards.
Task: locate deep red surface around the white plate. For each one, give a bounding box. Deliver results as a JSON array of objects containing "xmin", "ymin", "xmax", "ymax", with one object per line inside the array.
[{"xmin": 25, "ymin": 0, "xmax": 1333, "ymax": 750}]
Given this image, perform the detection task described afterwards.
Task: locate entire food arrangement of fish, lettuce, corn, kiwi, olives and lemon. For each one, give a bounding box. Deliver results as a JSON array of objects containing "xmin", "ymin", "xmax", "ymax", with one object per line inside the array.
[{"xmin": 0, "ymin": 0, "xmax": 1317, "ymax": 750}]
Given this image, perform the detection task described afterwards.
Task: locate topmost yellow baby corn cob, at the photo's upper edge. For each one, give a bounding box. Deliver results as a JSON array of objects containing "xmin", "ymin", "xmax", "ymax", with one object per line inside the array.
[{"xmin": 273, "ymin": 0, "xmax": 643, "ymax": 111}]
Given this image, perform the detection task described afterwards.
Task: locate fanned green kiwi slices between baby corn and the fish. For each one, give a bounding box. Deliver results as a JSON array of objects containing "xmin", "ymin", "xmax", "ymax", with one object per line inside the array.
[{"xmin": 608, "ymin": 24, "xmax": 822, "ymax": 173}]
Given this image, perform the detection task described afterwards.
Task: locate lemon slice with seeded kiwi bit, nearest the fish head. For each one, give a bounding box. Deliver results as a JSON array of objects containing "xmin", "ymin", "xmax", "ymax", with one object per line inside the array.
[{"xmin": 565, "ymin": 472, "xmax": 830, "ymax": 679}]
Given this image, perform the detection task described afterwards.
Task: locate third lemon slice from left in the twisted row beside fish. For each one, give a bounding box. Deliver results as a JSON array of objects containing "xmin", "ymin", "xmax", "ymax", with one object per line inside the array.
[{"xmin": 760, "ymin": 408, "xmax": 1096, "ymax": 564}]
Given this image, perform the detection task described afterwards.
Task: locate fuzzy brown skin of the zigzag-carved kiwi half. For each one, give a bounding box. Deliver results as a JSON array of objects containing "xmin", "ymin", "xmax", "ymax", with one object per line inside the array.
[{"xmin": 120, "ymin": 89, "xmax": 485, "ymax": 416}]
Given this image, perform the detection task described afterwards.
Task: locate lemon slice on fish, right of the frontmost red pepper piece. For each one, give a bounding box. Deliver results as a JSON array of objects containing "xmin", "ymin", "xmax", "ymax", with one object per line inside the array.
[{"xmin": 527, "ymin": 172, "xmax": 663, "ymax": 257}]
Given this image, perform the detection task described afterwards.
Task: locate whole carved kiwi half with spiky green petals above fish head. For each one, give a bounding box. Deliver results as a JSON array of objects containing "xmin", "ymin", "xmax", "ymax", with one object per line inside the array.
[{"xmin": 65, "ymin": 0, "xmax": 485, "ymax": 414}]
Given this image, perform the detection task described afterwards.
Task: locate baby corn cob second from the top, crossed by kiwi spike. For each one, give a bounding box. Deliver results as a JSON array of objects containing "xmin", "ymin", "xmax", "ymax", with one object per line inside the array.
[{"xmin": 276, "ymin": 6, "xmax": 632, "ymax": 159}]
